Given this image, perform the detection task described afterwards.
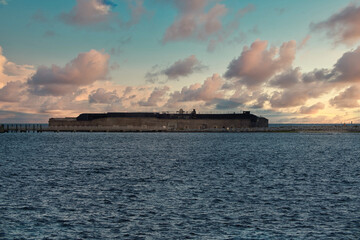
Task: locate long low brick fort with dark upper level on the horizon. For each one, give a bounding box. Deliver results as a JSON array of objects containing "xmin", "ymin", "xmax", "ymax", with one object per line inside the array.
[{"xmin": 49, "ymin": 109, "xmax": 268, "ymax": 132}]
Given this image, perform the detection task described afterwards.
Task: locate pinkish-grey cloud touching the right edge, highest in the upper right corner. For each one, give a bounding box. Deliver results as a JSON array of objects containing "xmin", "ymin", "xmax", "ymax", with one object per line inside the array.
[{"xmin": 310, "ymin": 3, "xmax": 360, "ymax": 45}]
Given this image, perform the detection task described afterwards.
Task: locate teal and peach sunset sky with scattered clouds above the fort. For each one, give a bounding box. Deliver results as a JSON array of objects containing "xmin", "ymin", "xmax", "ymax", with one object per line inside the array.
[{"xmin": 0, "ymin": 0, "xmax": 360, "ymax": 123}]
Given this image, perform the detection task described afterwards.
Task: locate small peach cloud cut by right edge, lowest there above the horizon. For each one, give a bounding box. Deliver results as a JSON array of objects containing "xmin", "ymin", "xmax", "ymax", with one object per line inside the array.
[{"xmin": 330, "ymin": 85, "xmax": 360, "ymax": 108}]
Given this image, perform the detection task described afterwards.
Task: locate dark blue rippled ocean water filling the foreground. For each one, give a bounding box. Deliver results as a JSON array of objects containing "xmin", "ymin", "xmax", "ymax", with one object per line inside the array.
[{"xmin": 0, "ymin": 133, "xmax": 360, "ymax": 239}]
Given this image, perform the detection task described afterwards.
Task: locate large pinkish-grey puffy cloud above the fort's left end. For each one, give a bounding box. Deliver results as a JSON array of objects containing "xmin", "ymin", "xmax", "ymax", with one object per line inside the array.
[{"xmin": 28, "ymin": 50, "xmax": 109, "ymax": 96}]
